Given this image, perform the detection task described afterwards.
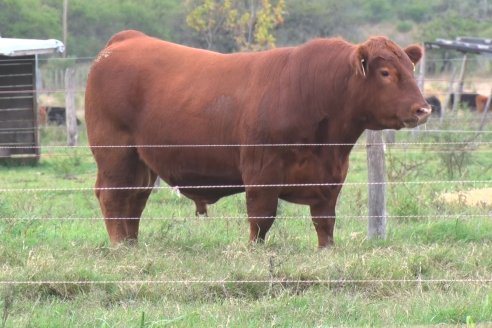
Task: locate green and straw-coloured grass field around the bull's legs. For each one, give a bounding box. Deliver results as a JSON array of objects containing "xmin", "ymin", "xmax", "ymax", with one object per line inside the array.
[{"xmin": 0, "ymin": 111, "xmax": 492, "ymax": 327}]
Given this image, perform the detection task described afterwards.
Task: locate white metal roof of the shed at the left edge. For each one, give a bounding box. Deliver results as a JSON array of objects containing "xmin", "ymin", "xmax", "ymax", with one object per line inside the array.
[{"xmin": 0, "ymin": 37, "xmax": 65, "ymax": 57}]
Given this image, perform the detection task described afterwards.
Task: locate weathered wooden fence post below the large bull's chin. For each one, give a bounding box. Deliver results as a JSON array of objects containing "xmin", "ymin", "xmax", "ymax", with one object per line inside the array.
[{"xmin": 367, "ymin": 130, "xmax": 386, "ymax": 239}]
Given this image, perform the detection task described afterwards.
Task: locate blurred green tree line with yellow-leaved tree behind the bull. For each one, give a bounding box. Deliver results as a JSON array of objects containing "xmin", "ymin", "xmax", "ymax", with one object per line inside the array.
[{"xmin": 0, "ymin": 0, "xmax": 492, "ymax": 57}]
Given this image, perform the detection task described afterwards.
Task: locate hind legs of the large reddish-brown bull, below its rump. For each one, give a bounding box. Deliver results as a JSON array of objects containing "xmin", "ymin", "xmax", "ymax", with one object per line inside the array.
[{"xmin": 94, "ymin": 148, "xmax": 156, "ymax": 245}]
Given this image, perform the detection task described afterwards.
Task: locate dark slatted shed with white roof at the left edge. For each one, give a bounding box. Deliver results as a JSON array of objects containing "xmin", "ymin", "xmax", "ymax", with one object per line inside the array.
[{"xmin": 0, "ymin": 37, "xmax": 65, "ymax": 163}]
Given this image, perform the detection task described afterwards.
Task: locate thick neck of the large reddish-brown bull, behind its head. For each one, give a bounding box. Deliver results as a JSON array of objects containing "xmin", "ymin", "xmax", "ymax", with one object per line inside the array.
[{"xmin": 292, "ymin": 40, "xmax": 365, "ymax": 154}]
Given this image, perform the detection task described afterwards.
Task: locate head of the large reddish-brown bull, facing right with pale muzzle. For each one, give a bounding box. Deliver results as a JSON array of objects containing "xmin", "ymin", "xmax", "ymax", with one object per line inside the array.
[{"xmin": 352, "ymin": 37, "xmax": 431, "ymax": 129}]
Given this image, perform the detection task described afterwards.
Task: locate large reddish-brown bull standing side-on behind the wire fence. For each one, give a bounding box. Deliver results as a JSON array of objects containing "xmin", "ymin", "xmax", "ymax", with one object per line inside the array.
[{"xmin": 85, "ymin": 31, "xmax": 431, "ymax": 247}]
